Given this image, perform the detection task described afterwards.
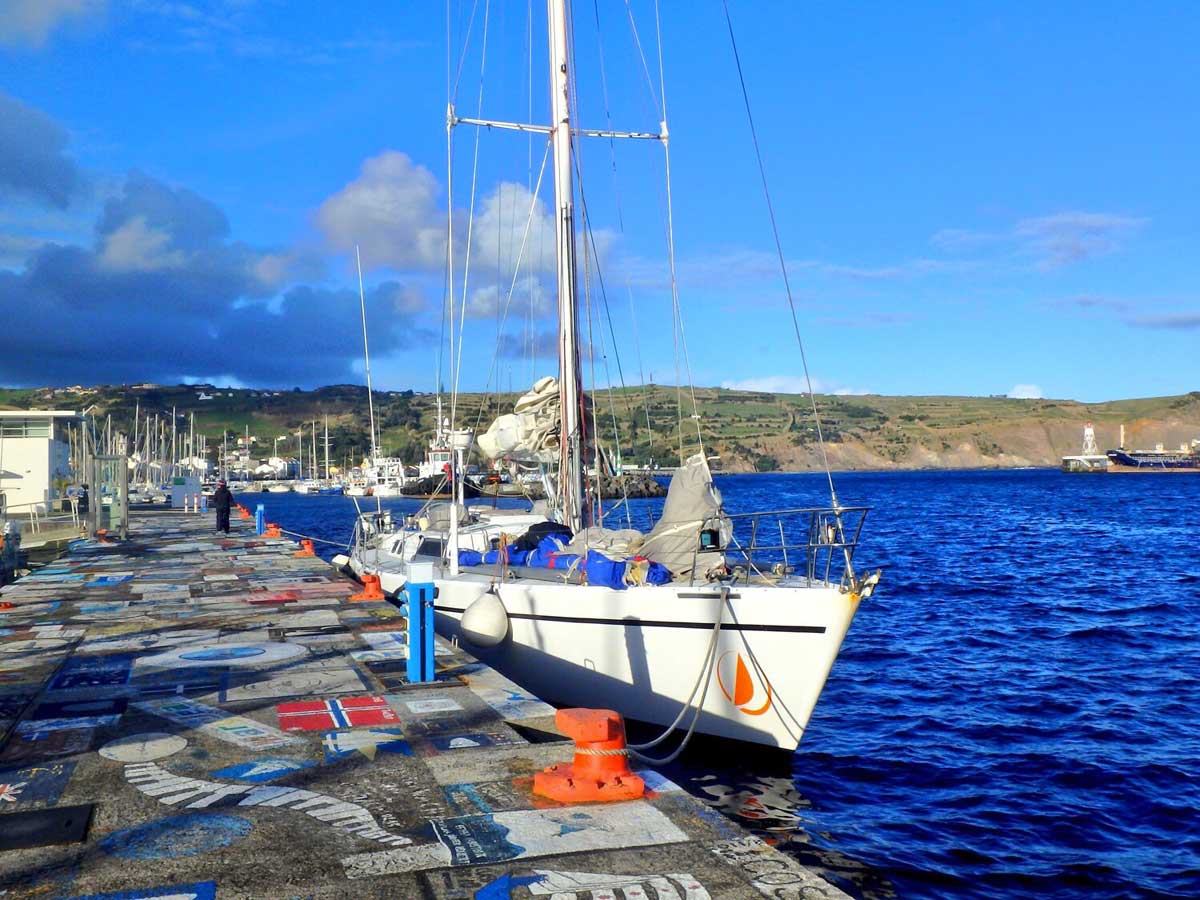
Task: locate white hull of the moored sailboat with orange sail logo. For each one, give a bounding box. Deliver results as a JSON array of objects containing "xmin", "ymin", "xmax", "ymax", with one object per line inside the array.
[{"xmin": 352, "ymin": 557, "xmax": 858, "ymax": 750}]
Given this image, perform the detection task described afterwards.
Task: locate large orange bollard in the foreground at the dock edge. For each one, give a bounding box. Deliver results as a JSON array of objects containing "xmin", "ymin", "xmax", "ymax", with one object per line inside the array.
[{"xmin": 533, "ymin": 708, "xmax": 646, "ymax": 803}]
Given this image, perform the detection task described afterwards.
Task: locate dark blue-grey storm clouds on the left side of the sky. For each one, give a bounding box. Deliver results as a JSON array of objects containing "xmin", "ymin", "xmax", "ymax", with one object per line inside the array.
[{"xmin": 0, "ymin": 95, "xmax": 432, "ymax": 385}]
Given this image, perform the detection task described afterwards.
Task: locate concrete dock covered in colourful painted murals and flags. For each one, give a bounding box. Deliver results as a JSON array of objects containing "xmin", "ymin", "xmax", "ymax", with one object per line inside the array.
[{"xmin": 0, "ymin": 510, "xmax": 842, "ymax": 900}]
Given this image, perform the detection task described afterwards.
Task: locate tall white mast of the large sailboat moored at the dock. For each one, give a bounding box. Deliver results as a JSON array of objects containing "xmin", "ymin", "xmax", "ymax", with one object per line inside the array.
[{"xmin": 546, "ymin": 0, "xmax": 583, "ymax": 532}]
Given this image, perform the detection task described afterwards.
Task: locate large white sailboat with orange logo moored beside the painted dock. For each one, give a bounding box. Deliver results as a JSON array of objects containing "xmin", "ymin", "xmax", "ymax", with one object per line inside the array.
[{"xmin": 340, "ymin": 0, "xmax": 878, "ymax": 750}]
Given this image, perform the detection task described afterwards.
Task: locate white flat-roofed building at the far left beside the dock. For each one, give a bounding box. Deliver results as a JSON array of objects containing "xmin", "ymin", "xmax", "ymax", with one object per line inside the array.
[{"xmin": 0, "ymin": 409, "xmax": 79, "ymax": 515}]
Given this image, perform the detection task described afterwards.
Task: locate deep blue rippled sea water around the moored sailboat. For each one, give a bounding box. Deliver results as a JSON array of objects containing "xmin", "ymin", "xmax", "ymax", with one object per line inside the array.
[{"xmin": 247, "ymin": 470, "xmax": 1200, "ymax": 899}]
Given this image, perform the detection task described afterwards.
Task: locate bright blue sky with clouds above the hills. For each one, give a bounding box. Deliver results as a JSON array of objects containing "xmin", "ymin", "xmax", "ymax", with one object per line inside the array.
[{"xmin": 0, "ymin": 0, "xmax": 1200, "ymax": 400}]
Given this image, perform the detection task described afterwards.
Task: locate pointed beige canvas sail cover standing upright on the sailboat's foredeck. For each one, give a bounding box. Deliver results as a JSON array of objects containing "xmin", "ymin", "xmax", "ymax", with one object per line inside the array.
[{"xmin": 638, "ymin": 454, "xmax": 733, "ymax": 577}]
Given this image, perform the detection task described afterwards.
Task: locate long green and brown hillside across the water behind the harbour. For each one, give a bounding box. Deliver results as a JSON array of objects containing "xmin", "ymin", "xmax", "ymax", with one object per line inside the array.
[{"xmin": 0, "ymin": 385, "xmax": 1200, "ymax": 472}]
